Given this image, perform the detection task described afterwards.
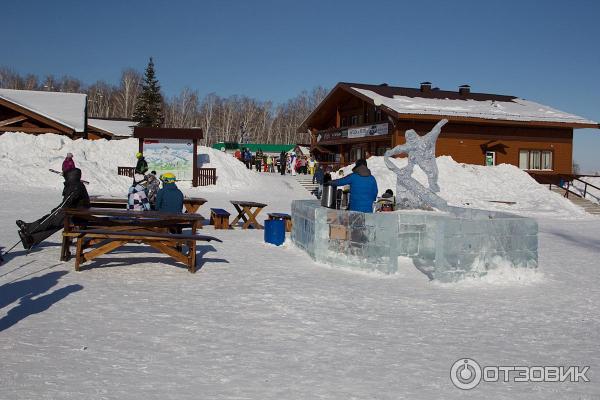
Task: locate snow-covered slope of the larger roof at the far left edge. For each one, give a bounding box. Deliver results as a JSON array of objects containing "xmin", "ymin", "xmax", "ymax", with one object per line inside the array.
[{"xmin": 0, "ymin": 89, "xmax": 87, "ymax": 132}]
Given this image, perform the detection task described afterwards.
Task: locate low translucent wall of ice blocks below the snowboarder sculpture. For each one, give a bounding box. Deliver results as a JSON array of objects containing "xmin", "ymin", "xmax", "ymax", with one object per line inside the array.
[{"xmin": 292, "ymin": 200, "xmax": 538, "ymax": 282}]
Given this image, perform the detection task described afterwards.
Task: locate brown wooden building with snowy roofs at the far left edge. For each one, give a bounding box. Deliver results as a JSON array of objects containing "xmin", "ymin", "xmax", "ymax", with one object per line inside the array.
[{"xmin": 0, "ymin": 89, "xmax": 137, "ymax": 139}]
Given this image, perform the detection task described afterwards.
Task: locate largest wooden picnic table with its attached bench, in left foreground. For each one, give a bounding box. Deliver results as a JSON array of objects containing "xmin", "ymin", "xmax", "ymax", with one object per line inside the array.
[{"xmin": 61, "ymin": 208, "xmax": 221, "ymax": 272}]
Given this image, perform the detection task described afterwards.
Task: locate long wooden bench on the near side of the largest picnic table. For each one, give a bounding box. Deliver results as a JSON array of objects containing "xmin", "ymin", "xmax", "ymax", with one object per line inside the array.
[{"xmin": 67, "ymin": 229, "xmax": 222, "ymax": 273}]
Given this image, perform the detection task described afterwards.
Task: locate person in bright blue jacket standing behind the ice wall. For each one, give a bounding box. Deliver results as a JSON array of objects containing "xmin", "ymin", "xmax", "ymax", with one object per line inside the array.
[{"xmin": 330, "ymin": 158, "xmax": 378, "ymax": 213}]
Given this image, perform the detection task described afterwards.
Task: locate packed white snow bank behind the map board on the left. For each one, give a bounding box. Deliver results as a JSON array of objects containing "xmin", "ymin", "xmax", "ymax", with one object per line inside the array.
[{"xmin": 0, "ymin": 132, "xmax": 256, "ymax": 196}]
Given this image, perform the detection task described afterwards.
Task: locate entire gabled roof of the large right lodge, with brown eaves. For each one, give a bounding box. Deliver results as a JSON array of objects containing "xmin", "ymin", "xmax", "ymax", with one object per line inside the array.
[{"xmin": 298, "ymin": 82, "xmax": 600, "ymax": 132}]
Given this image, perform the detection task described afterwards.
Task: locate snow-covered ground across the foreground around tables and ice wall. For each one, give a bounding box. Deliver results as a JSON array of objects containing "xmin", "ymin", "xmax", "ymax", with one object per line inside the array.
[{"xmin": 0, "ymin": 135, "xmax": 600, "ymax": 400}]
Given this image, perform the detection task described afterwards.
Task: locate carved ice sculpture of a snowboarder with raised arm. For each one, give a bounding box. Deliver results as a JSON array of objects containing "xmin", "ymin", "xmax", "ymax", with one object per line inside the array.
[{"xmin": 384, "ymin": 119, "xmax": 448, "ymax": 211}]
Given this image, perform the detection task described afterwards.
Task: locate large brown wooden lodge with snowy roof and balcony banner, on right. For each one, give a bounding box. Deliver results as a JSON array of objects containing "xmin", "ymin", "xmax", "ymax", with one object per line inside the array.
[{"xmin": 298, "ymin": 82, "xmax": 600, "ymax": 174}]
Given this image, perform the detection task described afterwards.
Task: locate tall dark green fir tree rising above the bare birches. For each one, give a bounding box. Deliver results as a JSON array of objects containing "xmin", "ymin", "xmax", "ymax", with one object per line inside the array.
[{"xmin": 133, "ymin": 57, "xmax": 165, "ymax": 128}]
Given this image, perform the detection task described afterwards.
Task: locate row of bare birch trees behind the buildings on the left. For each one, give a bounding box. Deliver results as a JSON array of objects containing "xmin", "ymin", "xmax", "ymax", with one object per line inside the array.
[{"xmin": 0, "ymin": 67, "xmax": 327, "ymax": 146}]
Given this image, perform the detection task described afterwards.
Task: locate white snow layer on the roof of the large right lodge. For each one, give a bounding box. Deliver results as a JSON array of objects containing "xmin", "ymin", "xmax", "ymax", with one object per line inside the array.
[{"xmin": 352, "ymin": 87, "xmax": 598, "ymax": 125}]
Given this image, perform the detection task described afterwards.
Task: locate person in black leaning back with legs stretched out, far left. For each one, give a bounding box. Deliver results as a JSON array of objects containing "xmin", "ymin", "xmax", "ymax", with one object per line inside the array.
[{"xmin": 16, "ymin": 168, "xmax": 90, "ymax": 250}]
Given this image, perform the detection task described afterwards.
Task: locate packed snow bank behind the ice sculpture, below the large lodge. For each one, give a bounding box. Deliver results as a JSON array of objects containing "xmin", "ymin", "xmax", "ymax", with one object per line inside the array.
[{"xmin": 333, "ymin": 156, "xmax": 589, "ymax": 218}]
